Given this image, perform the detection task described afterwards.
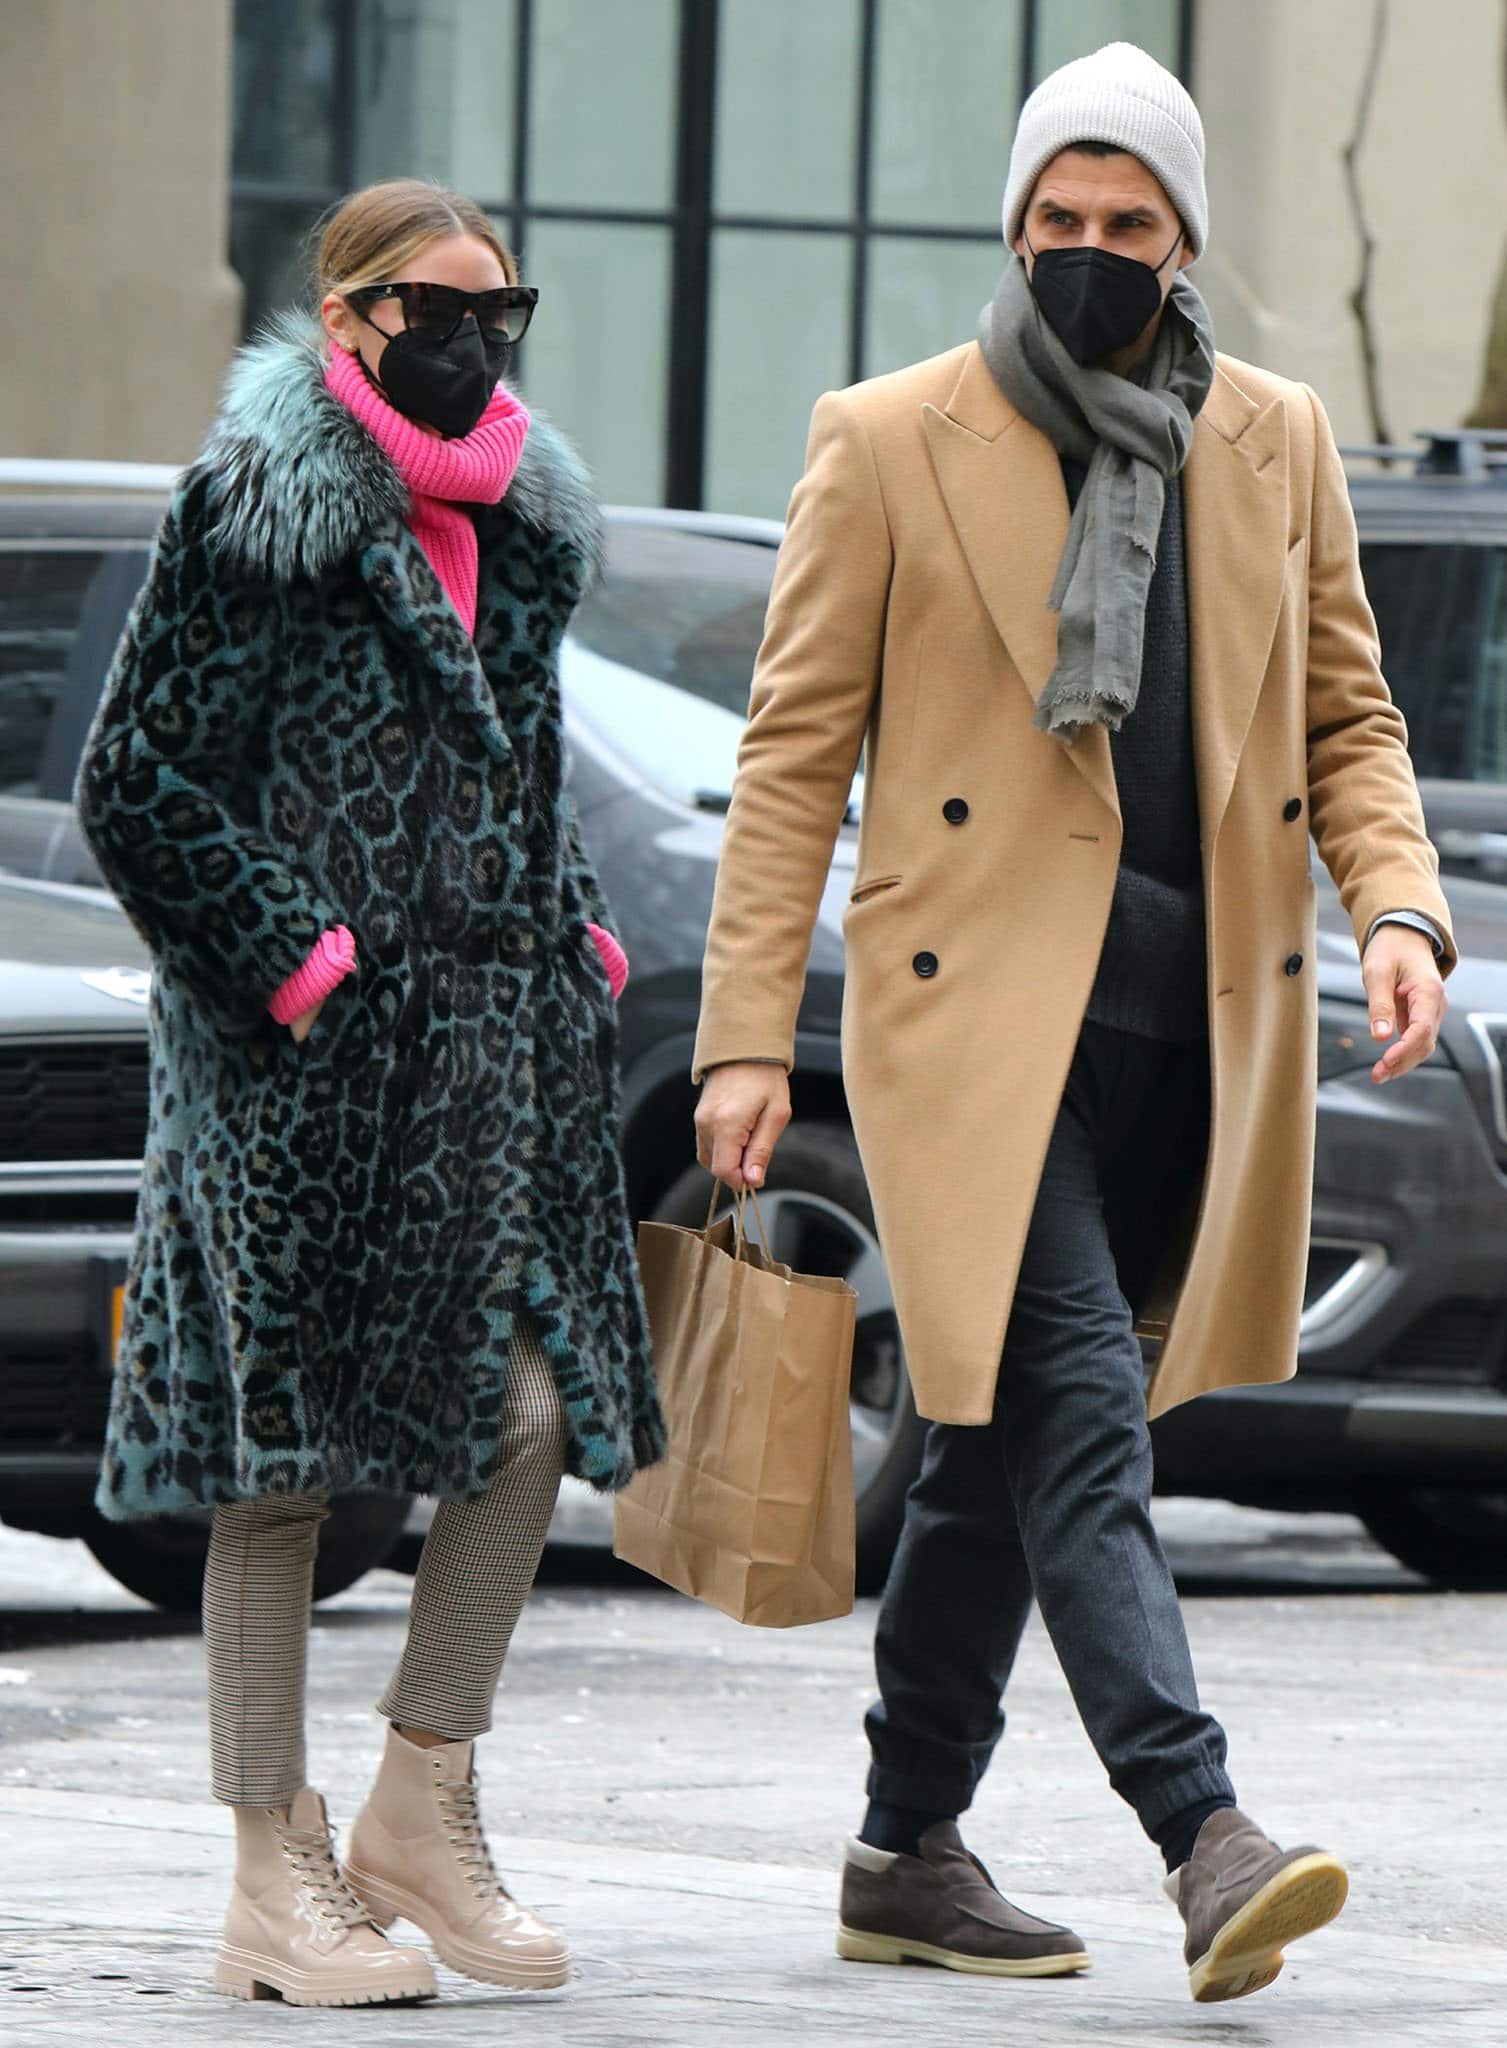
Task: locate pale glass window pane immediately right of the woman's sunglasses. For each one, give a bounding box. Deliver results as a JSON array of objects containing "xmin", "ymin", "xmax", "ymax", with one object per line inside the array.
[{"xmin": 520, "ymin": 221, "xmax": 670, "ymax": 504}]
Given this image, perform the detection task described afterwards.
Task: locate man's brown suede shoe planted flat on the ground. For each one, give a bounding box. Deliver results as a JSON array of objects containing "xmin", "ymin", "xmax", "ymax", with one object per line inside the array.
[{"xmin": 837, "ymin": 1821, "xmax": 1089, "ymax": 1976}]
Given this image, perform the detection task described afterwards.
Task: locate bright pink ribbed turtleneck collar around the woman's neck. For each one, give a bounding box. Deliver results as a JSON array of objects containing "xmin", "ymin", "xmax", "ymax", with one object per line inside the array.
[{"xmin": 324, "ymin": 342, "xmax": 528, "ymax": 633}]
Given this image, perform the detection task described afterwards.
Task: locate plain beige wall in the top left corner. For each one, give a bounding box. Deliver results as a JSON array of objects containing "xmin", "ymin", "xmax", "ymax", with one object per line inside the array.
[{"xmin": 0, "ymin": 0, "xmax": 240, "ymax": 461}]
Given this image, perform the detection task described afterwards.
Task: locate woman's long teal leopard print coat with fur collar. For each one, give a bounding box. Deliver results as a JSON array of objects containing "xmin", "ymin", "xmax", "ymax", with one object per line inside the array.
[{"xmin": 78, "ymin": 317, "xmax": 663, "ymax": 1520}]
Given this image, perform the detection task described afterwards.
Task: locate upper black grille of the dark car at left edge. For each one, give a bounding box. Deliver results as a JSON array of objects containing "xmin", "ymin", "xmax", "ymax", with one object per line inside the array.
[{"xmin": 0, "ymin": 1038, "xmax": 147, "ymax": 1165}]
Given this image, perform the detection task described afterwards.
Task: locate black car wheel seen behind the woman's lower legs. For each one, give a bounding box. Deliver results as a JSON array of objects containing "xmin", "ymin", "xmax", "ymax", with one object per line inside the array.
[{"xmin": 78, "ymin": 1493, "xmax": 410, "ymax": 1614}]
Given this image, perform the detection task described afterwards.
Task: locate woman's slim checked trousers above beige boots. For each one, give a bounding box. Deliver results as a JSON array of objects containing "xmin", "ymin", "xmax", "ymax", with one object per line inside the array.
[{"xmin": 205, "ymin": 1317, "xmax": 565, "ymax": 1806}]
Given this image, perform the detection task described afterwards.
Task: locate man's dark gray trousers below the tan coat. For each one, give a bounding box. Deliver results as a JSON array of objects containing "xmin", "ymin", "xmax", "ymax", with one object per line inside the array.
[{"xmin": 868, "ymin": 1022, "xmax": 1235, "ymax": 1835}]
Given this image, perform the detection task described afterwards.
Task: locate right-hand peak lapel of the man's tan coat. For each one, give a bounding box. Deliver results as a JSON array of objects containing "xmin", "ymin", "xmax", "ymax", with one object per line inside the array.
[{"xmin": 1183, "ymin": 371, "xmax": 1288, "ymax": 848}]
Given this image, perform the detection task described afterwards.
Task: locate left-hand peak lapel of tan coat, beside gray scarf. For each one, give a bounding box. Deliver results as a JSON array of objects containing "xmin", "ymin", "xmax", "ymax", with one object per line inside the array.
[{"xmin": 921, "ymin": 346, "xmax": 1118, "ymax": 815}]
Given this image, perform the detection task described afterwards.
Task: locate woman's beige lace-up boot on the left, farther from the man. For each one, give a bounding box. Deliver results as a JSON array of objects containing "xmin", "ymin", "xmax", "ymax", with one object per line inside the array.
[{"xmin": 215, "ymin": 1786, "xmax": 440, "ymax": 2005}]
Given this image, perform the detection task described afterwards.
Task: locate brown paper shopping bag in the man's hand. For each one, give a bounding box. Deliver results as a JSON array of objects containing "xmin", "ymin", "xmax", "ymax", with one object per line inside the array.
[{"xmin": 612, "ymin": 1188, "xmax": 858, "ymax": 1628}]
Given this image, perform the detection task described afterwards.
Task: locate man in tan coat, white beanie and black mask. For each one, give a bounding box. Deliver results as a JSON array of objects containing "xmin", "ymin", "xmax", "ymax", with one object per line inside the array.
[{"xmin": 694, "ymin": 43, "xmax": 1454, "ymax": 2001}]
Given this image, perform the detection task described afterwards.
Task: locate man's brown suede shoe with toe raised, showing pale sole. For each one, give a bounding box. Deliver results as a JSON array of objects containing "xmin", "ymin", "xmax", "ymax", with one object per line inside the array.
[{"xmin": 1163, "ymin": 1806, "xmax": 1349, "ymax": 2005}]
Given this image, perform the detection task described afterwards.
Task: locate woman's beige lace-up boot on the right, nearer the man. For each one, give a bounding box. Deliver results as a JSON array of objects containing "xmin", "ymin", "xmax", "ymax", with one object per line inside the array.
[{"xmin": 344, "ymin": 1722, "xmax": 571, "ymax": 1991}]
